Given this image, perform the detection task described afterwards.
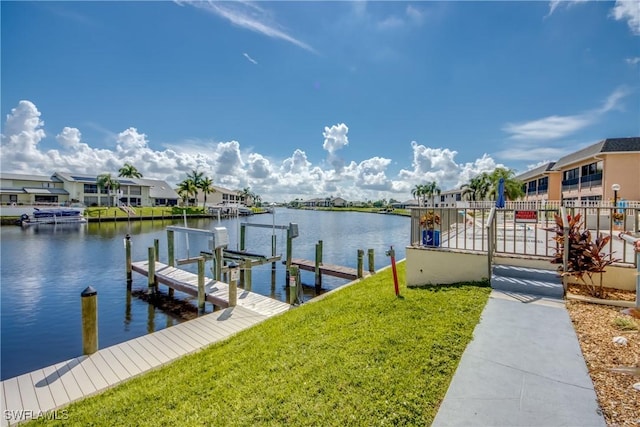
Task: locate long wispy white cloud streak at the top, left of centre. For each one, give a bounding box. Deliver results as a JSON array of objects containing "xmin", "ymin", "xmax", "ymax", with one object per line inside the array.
[{"xmin": 176, "ymin": 0, "xmax": 316, "ymax": 53}]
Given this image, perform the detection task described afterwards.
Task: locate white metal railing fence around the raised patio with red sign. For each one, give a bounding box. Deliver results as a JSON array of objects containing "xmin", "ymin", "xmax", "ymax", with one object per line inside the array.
[{"xmin": 410, "ymin": 206, "xmax": 640, "ymax": 264}]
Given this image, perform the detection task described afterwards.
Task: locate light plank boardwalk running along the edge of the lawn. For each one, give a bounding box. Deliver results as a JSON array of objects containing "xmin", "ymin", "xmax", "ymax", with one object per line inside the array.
[{"xmin": 0, "ymin": 286, "xmax": 290, "ymax": 426}]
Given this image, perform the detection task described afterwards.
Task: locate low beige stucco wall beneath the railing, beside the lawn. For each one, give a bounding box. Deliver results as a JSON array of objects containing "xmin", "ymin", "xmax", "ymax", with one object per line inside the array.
[{"xmin": 406, "ymin": 247, "xmax": 488, "ymax": 287}]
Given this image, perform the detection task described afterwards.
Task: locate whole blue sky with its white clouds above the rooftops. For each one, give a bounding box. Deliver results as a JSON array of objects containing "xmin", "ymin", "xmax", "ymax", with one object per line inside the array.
[{"xmin": 1, "ymin": 0, "xmax": 640, "ymax": 201}]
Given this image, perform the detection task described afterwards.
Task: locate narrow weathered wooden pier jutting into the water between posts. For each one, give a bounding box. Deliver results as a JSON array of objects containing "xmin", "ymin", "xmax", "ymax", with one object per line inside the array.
[{"xmin": 131, "ymin": 261, "xmax": 289, "ymax": 315}]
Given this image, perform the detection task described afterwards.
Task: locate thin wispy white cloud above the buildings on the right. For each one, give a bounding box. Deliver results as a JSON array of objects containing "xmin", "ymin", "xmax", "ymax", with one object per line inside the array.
[{"xmin": 502, "ymin": 87, "xmax": 631, "ymax": 140}]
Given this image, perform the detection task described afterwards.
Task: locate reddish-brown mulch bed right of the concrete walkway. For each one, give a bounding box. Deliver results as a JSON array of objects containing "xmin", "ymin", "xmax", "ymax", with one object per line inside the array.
[{"xmin": 566, "ymin": 286, "xmax": 640, "ymax": 426}]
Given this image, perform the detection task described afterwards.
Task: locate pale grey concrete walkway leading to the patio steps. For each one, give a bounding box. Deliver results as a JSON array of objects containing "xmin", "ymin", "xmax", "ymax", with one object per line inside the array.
[{"xmin": 433, "ymin": 290, "xmax": 606, "ymax": 427}]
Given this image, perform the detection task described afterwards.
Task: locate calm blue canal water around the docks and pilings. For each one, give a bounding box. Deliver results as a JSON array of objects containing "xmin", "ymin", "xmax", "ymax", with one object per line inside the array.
[{"xmin": 0, "ymin": 208, "xmax": 410, "ymax": 379}]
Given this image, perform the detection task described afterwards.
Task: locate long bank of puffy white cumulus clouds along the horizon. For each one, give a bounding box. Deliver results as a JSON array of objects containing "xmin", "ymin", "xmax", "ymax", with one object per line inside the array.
[{"xmin": 1, "ymin": 101, "xmax": 512, "ymax": 205}]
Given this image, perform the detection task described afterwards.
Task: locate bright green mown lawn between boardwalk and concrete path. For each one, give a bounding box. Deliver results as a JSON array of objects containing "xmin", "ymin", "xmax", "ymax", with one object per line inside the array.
[{"xmin": 28, "ymin": 263, "xmax": 490, "ymax": 426}]
